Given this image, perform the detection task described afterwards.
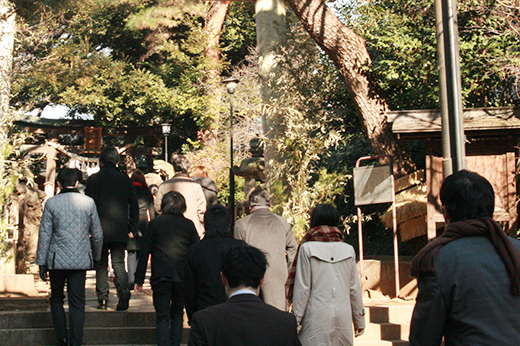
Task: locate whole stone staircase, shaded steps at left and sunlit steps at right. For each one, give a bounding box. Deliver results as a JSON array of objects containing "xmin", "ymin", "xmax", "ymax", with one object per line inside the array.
[{"xmin": 0, "ymin": 300, "xmax": 414, "ymax": 346}]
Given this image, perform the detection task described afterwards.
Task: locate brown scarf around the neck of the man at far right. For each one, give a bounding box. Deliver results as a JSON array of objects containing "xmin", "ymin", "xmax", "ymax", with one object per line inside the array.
[{"xmin": 412, "ymin": 217, "xmax": 520, "ymax": 296}]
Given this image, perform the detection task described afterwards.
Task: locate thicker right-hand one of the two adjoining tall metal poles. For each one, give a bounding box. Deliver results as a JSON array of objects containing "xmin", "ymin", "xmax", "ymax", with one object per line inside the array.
[{"xmin": 442, "ymin": 0, "xmax": 466, "ymax": 172}]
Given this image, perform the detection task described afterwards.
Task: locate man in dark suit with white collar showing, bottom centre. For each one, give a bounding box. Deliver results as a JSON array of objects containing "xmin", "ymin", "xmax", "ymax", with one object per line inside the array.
[{"xmin": 188, "ymin": 244, "xmax": 300, "ymax": 346}]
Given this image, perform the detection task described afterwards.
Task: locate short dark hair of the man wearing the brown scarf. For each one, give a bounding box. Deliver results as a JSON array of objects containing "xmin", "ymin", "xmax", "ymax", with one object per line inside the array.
[{"xmin": 440, "ymin": 170, "xmax": 495, "ymax": 222}]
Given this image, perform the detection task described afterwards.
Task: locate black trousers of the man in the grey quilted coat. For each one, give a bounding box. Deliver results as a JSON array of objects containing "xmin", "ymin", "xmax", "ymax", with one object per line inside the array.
[{"xmin": 49, "ymin": 270, "xmax": 87, "ymax": 346}]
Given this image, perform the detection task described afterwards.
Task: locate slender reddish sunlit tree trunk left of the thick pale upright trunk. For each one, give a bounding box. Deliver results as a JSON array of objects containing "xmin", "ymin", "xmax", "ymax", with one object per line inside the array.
[{"xmin": 201, "ymin": 0, "xmax": 231, "ymax": 143}]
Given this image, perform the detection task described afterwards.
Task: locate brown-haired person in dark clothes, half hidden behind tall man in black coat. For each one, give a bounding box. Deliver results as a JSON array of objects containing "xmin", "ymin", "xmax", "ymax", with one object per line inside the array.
[{"xmin": 126, "ymin": 169, "xmax": 155, "ymax": 288}]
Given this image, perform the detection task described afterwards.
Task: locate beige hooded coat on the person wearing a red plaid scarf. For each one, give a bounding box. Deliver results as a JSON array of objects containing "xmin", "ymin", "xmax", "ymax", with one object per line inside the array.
[{"xmin": 293, "ymin": 241, "xmax": 365, "ymax": 346}]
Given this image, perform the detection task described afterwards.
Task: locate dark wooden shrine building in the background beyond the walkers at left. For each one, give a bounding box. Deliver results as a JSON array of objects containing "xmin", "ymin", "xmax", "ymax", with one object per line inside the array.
[{"xmin": 15, "ymin": 116, "xmax": 164, "ymax": 197}]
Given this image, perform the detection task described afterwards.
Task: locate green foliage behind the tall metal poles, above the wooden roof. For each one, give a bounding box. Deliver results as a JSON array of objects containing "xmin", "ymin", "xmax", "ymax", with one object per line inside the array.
[{"xmin": 342, "ymin": 0, "xmax": 520, "ymax": 109}]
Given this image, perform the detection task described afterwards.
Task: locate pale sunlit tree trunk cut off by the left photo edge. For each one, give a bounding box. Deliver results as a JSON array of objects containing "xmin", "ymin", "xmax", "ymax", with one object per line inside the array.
[{"xmin": 0, "ymin": 0, "xmax": 16, "ymax": 118}]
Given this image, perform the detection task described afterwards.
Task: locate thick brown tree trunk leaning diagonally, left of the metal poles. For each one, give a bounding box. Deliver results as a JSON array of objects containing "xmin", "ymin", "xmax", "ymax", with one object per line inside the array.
[{"xmin": 287, "ymin": 0, "xmax": 416, "ymax": 176}]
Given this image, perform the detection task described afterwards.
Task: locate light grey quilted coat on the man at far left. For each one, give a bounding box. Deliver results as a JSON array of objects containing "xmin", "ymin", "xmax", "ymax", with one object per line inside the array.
[{"xmin": 36, "ymin": 192, "xmax": 103, "ymax": 270}]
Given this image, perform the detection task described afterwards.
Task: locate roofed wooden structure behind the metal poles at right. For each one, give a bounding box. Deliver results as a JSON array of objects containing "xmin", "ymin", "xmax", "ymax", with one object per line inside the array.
[{"xmin": 388, "ymin": 108, "xmax": 520, "ymax": 240}]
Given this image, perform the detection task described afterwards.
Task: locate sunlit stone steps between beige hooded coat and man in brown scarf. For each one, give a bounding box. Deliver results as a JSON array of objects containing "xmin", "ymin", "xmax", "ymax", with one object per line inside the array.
[{"xmin": 354, "ymin": 299, "xmax": 415, "ymax": 346}]
